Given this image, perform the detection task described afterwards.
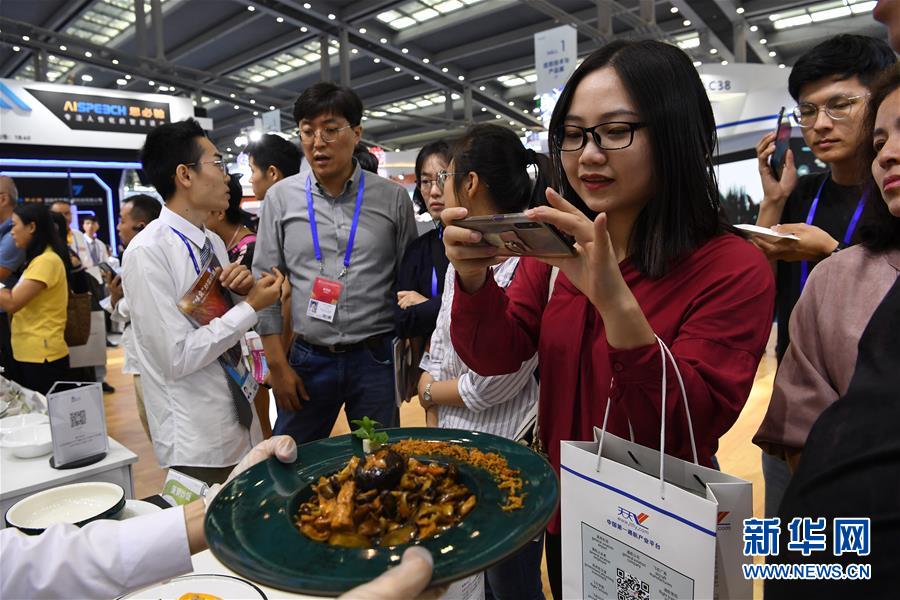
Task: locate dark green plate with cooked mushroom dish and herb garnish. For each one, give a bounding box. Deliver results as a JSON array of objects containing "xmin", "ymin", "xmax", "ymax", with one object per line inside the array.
[{"xmin": 205, "ymin": 428, "xmax": 559, "ymax": 596}]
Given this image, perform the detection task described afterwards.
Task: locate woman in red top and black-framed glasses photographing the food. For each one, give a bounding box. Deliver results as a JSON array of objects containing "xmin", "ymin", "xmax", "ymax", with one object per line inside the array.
[{"xmin": 442, "ymin": 41, "xmax": 774, "ymax": 598}]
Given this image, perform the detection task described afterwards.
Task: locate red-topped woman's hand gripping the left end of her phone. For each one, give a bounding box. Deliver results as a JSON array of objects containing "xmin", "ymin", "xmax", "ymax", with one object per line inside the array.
[{"xmin": 441, "ymin": 207, "xmax": 505, "ymax": 294}]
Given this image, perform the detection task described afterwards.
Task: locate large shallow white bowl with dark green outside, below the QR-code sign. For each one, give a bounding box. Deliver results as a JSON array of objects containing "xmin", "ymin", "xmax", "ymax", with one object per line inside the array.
[{"xmin": 5, "ymin": 481, "xmax": 125, "ymax": 535}]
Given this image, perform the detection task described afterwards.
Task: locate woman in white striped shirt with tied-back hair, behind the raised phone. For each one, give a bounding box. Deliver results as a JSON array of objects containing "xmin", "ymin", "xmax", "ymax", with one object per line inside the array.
[{"xmin": 418, "ymin": 124, "xmax": 547, "ymax": 600}]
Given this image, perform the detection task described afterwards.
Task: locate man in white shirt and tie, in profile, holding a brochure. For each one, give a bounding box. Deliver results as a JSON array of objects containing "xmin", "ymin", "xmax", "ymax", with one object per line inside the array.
[{"xmin": 122, "ymin": 119, "xmax": 284, "ymax": 483}]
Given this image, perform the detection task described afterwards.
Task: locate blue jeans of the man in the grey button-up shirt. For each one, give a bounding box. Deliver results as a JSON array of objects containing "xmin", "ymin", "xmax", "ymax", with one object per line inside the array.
[{"xmin": 272, "ymin": 336, "xmax": 400, "ymax": 444}]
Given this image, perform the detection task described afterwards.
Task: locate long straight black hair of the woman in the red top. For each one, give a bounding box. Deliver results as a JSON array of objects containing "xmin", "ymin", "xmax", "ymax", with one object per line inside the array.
[{"xmin": 550, "ymin": 40, "xmax": 735, "ymax": 279}]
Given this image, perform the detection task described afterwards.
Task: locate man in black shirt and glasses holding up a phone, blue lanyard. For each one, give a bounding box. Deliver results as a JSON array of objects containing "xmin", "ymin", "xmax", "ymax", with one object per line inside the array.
[{"xmin": 753, "ymin": 35, "xmax": 895, "ymax": 516}]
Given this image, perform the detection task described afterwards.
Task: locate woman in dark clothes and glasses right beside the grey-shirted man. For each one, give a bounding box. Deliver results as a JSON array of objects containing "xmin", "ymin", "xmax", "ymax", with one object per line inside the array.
[{"xmin": 394, "ymin": 140, "xmax": 450, "ymax": 400}]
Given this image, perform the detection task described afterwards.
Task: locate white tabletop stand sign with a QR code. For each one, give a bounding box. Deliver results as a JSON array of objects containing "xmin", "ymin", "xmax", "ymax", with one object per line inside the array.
[{"xmin": 47, "ymin": 381, "xmax": 108, "ymax": 467}]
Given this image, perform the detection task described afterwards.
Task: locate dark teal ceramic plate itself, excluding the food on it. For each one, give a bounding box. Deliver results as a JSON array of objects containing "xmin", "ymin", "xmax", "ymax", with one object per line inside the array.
[{"xmin": 206, "ymin": 428, "xmax": 559, "ymax": 596}]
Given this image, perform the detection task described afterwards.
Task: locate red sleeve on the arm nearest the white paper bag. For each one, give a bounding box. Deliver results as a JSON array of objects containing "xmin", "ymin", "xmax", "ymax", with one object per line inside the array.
[{"xmin": 609, "ymin": 244, "xmax": 775, "ymax": 464}]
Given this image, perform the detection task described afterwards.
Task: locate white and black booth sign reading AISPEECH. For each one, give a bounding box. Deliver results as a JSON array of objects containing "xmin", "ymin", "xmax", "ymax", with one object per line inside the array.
[{"xmin": 0, "ymin": 79, "xmax": 194, "ymax": 150}]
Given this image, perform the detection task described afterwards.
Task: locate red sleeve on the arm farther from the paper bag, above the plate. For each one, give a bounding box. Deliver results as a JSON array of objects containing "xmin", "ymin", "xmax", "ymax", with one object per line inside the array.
[{"xmin": 450, "ymin": 258, "xmax": 550, "ymax": 376}]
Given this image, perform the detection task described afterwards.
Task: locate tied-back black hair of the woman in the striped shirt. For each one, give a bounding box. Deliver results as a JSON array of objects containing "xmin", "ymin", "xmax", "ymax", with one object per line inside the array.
[{"xmin": 452, "ymin": 123, "xmax": 550, "ymax": 213}]
